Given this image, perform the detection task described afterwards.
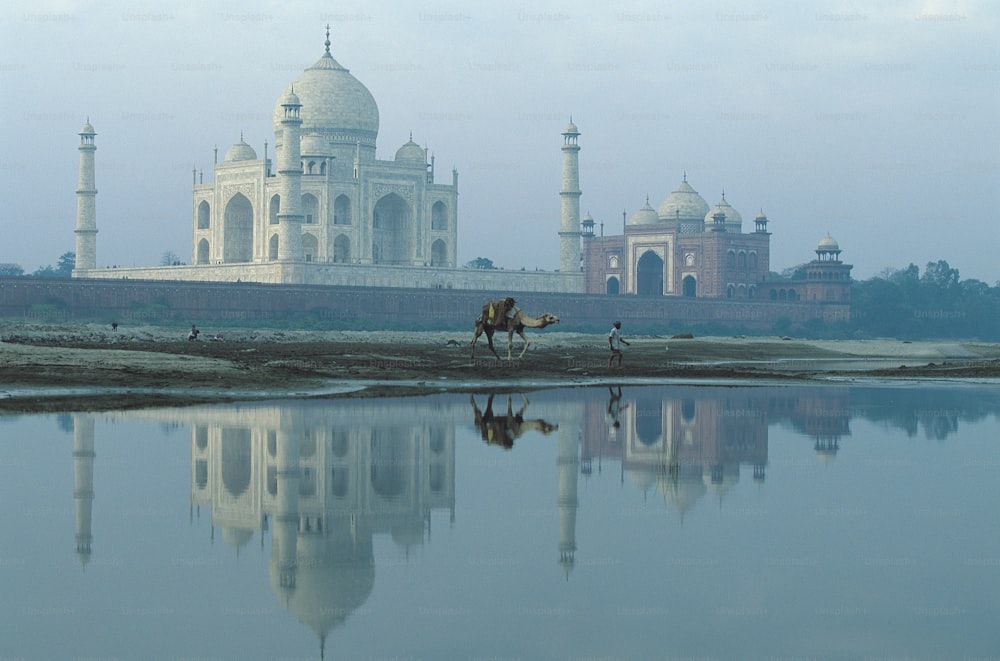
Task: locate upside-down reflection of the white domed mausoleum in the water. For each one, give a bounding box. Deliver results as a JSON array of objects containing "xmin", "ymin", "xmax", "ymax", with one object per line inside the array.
[{"xmin": 191, "ymin": 400, "xmax": 456, "ymax": 652}]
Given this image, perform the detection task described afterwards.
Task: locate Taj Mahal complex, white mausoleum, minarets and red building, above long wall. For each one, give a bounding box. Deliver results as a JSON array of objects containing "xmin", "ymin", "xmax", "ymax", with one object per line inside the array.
[{"xmin": 73, "ymin": 27, "xmax": 851, "ymax": 304}]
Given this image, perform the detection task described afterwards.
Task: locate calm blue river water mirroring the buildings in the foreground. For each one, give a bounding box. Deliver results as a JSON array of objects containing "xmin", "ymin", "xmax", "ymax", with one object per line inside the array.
[{"xmin": 0, "ymin": 384, "xmax": 1000, "ymax": 659}]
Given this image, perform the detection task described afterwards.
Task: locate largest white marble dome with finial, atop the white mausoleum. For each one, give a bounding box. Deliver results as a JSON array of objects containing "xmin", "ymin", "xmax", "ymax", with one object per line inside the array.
[{"xmin": 273, "ymin": 33, "xmax": 378, "ymax": 149}]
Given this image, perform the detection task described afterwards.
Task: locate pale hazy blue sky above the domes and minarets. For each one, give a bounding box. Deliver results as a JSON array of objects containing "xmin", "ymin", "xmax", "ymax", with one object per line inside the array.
[{"xmin": 0, "ymin": 0, "xmax": 1000, "ymax": 284}]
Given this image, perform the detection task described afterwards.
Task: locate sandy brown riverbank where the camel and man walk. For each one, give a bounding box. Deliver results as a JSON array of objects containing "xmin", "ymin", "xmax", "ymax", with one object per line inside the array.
[{"xmin": 0, "ymin": 320, "xmax": 1000, "ymax": 411}]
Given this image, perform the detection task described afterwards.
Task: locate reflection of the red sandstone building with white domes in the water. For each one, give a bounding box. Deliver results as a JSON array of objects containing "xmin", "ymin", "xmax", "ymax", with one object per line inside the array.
[{"xmin": 581, "ymin": 386, "xmax": 851, "ymax": 520}]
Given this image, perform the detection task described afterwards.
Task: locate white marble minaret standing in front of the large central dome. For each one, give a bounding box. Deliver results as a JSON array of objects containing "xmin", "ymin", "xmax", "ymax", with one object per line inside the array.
[{"xmin": 278, "ymin": 88, "xmax": 302, "ymax": 262}]
